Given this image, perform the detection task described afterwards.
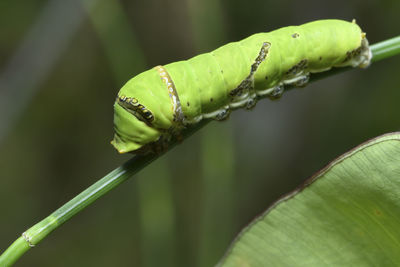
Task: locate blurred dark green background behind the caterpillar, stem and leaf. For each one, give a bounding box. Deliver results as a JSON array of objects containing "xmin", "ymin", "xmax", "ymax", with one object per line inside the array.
[{"xmin": 0, "ymin": 0, "xmax": 400, "ymax": 266}]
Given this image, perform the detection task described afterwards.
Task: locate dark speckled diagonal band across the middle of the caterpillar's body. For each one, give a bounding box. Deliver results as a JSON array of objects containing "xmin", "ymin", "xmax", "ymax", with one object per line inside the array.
[{"xmin": 229, "ymin": 42, "xmax": 271, "ymax": 97}]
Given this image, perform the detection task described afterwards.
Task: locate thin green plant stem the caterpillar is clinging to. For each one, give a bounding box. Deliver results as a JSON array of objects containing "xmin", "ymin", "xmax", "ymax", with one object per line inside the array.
[{"xmin": 0, "ymin": 36, "xmax": 400, "ymax": 267}]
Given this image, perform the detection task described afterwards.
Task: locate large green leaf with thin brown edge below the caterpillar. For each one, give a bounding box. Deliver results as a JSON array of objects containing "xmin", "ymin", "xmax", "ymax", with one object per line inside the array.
[{"xmin": 220, "ymin": 133, "xmax": 400, "ymax": 266}]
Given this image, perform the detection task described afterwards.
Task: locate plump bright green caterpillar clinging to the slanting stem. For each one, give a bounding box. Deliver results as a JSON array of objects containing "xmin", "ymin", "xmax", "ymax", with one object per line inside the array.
[{"xmin": 111, "ymin": 20, "xmax": 372, "ymax": 153}]
